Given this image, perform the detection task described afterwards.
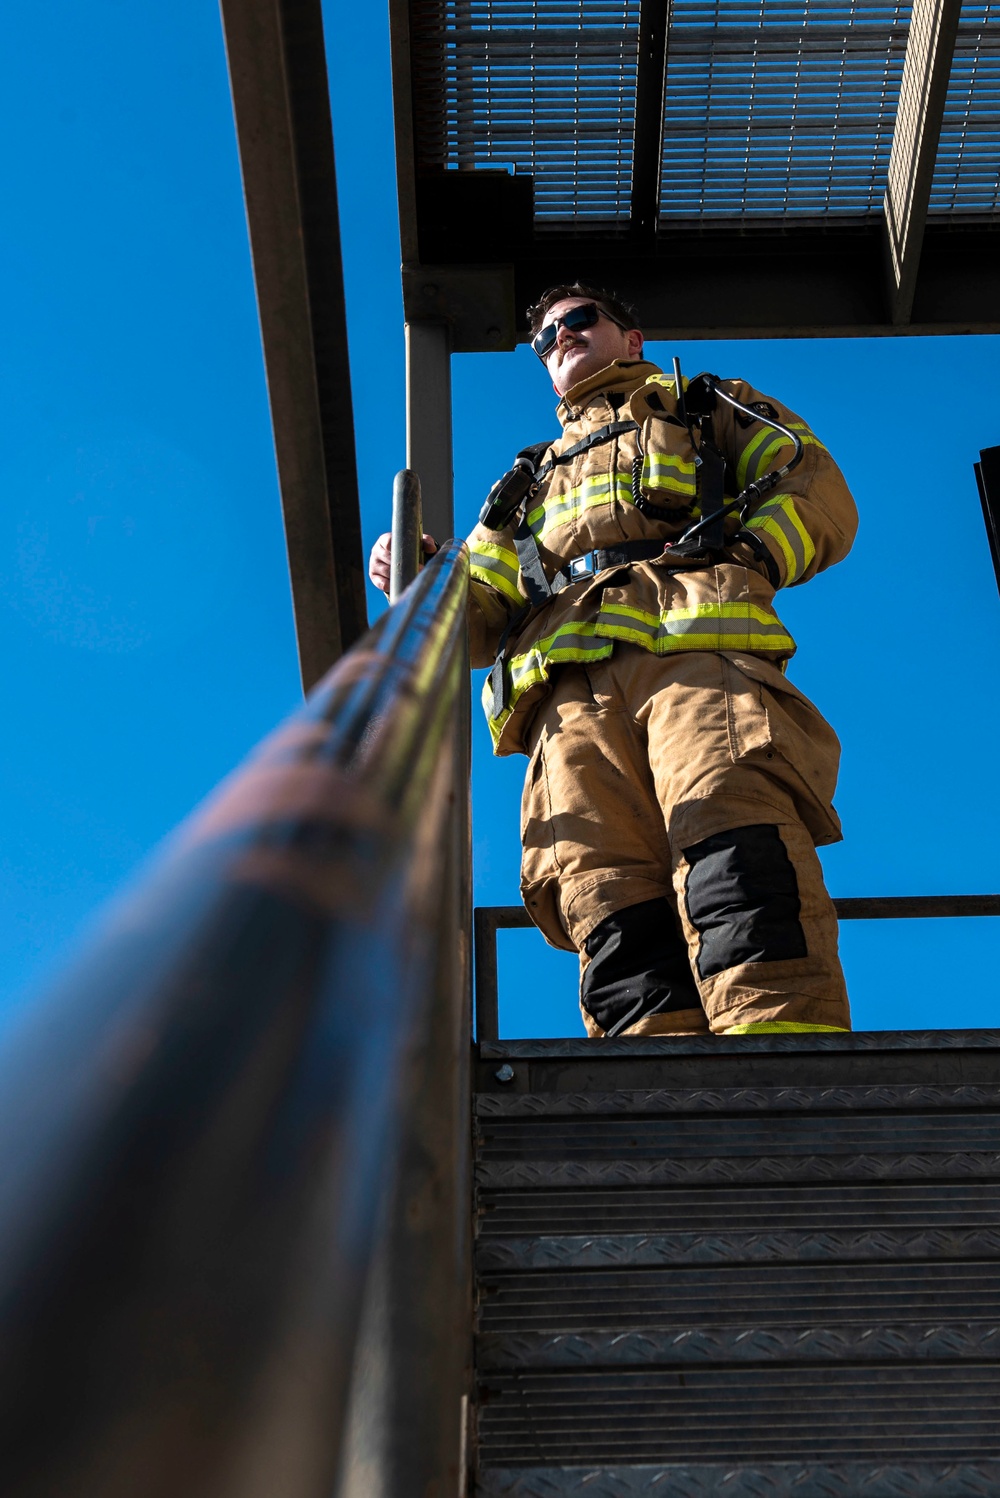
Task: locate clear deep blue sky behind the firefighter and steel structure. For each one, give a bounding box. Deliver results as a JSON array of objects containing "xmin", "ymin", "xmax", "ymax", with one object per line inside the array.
[{"xmin": 0, "ymin": 0, "xmax": 1000, "ymax": 1035}]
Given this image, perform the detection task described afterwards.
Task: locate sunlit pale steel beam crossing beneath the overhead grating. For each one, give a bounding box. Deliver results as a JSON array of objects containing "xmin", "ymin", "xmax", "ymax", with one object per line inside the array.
[{"xmin": 883, "ymin": 0, "xmax": 961, "ymax": 325}]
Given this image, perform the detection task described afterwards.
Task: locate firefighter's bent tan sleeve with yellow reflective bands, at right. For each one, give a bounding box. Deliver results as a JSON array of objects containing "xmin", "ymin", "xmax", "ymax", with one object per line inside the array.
[{"xmin": 714, "ymin": 380, "xmax": 858, "ymax": 587}]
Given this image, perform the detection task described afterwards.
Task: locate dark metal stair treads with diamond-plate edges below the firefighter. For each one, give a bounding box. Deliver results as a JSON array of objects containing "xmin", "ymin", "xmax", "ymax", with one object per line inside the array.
[{"xmin": 475, "ymin": 1031, "xmax": 1000, "ymax": 1498}]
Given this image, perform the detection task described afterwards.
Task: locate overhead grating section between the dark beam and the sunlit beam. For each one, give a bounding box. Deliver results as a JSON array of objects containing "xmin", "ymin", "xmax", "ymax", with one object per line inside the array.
[{"xmin": 660, "ymin": 0, "xmax": 910, "ymax": 219}]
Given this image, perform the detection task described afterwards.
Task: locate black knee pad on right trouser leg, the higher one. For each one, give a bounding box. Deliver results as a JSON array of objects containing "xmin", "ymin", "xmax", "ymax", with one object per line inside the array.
[{"xmin": 684, "ymin": 824, "xmax": 807, "ymax": 978}]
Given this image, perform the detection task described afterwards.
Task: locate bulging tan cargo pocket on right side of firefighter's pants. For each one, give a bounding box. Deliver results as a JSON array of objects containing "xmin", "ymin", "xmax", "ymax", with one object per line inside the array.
[{"xmin": 722, "ymin": 655, "xmax": 843, "ymax": 843}]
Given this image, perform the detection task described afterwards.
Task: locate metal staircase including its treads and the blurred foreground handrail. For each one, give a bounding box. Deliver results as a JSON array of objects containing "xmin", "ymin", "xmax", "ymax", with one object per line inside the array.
[{"xmin": 0, "ymin": 526, "xmax": 1000, "ymax": 1498}]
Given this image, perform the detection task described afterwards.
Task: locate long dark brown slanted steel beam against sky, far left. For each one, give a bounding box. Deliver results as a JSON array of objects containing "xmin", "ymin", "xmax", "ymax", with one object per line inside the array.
[{"xmin": 220, "ymin": 0, "xmax": 367, "ymax": 689}]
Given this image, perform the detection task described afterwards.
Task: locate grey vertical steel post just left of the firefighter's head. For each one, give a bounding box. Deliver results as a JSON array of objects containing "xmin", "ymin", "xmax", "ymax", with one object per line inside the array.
[{"xmin": 406, "ymin": 321, "xmax": 455, "ymax": 544}]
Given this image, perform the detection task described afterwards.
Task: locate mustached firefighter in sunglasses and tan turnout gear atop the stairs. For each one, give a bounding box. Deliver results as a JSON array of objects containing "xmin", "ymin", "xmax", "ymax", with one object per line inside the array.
[{"xmin": 370, "ymin": 283, "xmax": 858, "ymax": 1037}]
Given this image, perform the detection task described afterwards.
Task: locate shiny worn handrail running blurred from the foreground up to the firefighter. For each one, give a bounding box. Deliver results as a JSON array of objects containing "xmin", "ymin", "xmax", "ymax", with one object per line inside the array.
[{"xmin": 0, "ymin": 542, "xmax": 472, "ymax": 1498}]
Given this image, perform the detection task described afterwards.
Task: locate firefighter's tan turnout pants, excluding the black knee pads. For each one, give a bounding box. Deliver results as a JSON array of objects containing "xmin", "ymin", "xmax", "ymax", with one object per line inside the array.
[{"xmin": 521, "ymin": 646, "xmax": 850, "ymax": 1035}]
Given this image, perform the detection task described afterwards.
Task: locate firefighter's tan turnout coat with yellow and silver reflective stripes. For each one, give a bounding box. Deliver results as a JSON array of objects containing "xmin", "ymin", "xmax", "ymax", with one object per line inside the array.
[{"xmin": 470, "ymin": 360, "xmax": 858, "ymax": 755}]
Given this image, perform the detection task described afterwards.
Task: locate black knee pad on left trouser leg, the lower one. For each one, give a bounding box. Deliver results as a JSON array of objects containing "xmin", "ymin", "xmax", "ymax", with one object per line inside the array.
[{"xmin": 579, "ymin": 897, "xmax": 701, "ymax": 1034}]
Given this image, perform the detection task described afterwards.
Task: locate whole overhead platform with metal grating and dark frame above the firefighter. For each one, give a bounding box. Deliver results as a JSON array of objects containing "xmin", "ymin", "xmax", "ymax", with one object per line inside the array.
[{"xmin": 391, "ymin": 0, "xmax": 1000, "ymax": 349}]
